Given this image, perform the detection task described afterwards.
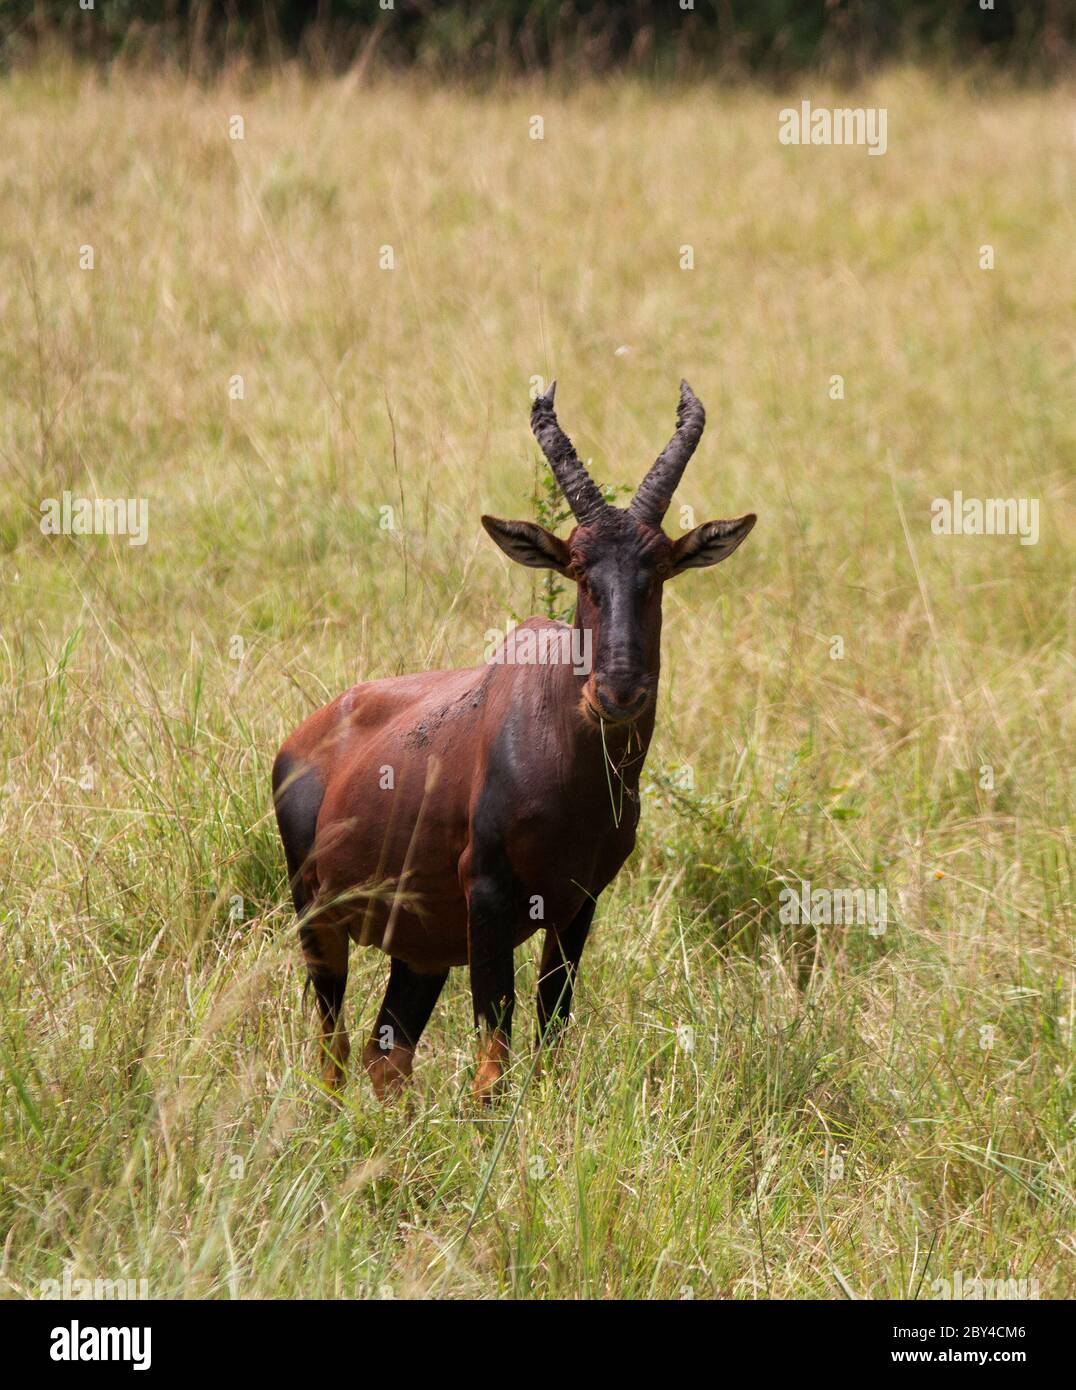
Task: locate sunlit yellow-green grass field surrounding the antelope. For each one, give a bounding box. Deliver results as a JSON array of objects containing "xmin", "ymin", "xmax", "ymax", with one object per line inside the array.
[{"xmin": 0, "ymin": 64, "xmax": 1076, "ymax": 1298}]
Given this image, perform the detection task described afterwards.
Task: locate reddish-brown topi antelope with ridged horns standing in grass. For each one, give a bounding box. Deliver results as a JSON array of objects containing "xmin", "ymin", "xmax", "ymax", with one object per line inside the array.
[{"xmin": 272, "ymin": 381, "xmax": 755, "ymax": 1099}]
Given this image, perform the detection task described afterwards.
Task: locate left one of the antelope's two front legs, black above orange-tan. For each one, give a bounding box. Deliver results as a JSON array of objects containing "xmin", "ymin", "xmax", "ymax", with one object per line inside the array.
[{"xmin": 467, "ymin": 878, "xmax": 516, "ymax": 1104}]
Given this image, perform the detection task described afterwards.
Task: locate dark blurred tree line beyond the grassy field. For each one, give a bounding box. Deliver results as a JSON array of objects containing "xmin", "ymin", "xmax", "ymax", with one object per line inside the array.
[{"xmin": 0, "ymin": 0, "xmax": 1076, "ymax": 76}]
